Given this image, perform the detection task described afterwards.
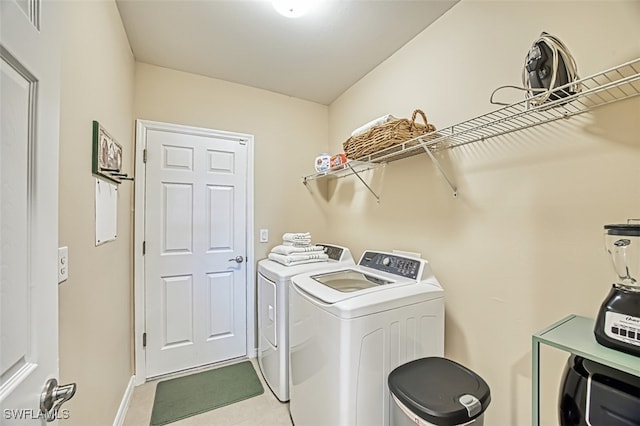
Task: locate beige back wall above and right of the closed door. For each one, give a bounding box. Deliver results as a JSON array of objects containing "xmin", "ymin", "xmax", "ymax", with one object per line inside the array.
[{"xmin": 135, "ymin": 63, "xmax": 328, "ymax": 259}]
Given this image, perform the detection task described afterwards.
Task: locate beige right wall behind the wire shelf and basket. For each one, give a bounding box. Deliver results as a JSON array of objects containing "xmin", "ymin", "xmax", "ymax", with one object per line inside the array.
[{"xmin": 328, "ymin": 1, "xmax": 640, "ymax": 425}]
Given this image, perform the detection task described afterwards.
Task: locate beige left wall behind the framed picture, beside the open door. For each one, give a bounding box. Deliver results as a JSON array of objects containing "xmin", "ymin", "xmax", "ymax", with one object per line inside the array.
[{"xmin": 59, "ymin": 1, "xmax": 135, "ymax": 425}]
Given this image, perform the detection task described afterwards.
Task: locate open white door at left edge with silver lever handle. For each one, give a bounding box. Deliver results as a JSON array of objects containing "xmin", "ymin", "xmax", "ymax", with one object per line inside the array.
[{"xmin": 0, "ymin": 0, "xmax": 75, "ymax": 425}]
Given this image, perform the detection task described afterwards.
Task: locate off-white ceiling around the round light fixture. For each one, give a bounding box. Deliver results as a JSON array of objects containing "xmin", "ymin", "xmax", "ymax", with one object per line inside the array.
[{"xmin": 116, "ymin": 0, "xmax": 459, "ymax": 105}]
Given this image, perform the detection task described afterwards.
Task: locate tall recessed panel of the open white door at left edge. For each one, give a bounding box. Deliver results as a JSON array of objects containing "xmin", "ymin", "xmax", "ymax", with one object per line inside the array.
[{"xmin": 0, "ymin": 57, "xmax": 35, "ymax": 383}]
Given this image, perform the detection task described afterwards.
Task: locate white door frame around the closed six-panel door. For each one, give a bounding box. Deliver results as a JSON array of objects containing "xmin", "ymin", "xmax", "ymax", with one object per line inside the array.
[{"xmin": 133, "ymin": 119, "xmax": 256, "ymax": 385}]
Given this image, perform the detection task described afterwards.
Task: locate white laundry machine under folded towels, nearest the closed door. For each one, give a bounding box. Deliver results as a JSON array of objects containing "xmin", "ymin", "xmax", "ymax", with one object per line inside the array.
[{"xmin": 258, "ymin": 244, "xmax": 355, "ymax": 402}]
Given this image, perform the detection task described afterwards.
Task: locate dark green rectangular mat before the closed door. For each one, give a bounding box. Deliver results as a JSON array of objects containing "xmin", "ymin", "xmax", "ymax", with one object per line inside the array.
[{"xmin": 150, "ymin": 361, "xmax": 264, "ymax": 426}]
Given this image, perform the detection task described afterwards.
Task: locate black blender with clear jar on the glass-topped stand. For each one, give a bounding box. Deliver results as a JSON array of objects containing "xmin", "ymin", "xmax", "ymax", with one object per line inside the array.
[{"xmin": 594, "ymin": 219, "xmax": 640, "ymax": 356}]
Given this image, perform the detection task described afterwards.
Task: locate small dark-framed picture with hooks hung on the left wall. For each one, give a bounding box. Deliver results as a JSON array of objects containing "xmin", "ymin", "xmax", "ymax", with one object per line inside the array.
[{"xmin": 91, "ymin": 121, "xmax": 126, "ymax": 183}]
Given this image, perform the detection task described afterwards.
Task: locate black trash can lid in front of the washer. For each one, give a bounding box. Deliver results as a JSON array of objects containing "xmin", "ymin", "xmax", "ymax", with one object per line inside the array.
[{"xmin": 388, "ymin": 357, "xmax": 491, "ymax": 426}]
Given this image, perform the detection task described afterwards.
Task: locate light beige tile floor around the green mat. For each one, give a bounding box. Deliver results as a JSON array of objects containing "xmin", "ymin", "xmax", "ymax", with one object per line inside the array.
[{"xmin": 124, "ymin": 358, "xmax": 292, "ymax": 426}]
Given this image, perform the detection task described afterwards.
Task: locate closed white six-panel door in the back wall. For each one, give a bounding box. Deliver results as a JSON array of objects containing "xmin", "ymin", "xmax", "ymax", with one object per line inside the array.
[{"xmin": 144, "ymin": 121, "xmax": 247, "ymax": 377}]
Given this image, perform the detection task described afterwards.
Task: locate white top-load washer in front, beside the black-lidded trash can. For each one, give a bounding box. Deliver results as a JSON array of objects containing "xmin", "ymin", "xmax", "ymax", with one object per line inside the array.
[{"xmin": 289, "ymin": 251, "xmax": 444, "ymax": 426}]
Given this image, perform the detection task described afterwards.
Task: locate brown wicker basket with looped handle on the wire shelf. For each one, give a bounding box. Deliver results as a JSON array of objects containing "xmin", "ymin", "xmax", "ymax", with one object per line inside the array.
[{"xmin": 342, "ymin": 109, "xmax": 436, "ymax": 160}]
